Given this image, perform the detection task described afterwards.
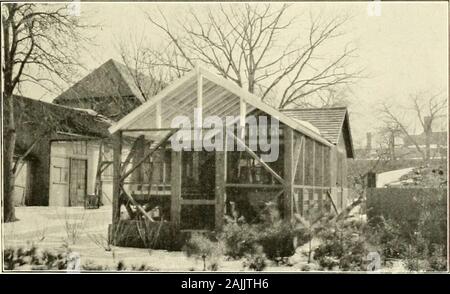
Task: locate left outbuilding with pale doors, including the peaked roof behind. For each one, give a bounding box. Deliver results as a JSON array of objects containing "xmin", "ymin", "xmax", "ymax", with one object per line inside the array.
[{"xmin": 14, "ymin": 59, "xmax": 162, "ymax": 206}]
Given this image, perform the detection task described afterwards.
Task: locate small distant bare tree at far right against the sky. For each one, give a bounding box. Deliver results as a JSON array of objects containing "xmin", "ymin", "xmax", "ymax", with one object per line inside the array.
[{"xmin": 380, "ymin": 92, "xmax": 447, "ymax": 161}]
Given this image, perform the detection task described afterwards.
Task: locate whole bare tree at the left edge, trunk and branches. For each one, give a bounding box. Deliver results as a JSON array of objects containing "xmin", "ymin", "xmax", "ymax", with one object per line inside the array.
[{"xmin": 2, "ymin": 3, "xmax": 91, "ymax": 222}]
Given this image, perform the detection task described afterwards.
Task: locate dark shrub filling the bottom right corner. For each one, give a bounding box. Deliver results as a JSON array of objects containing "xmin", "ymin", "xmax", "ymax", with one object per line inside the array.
[{"xmin": 367, "ymin": 190, "xmax": 447, "ymax": 271}]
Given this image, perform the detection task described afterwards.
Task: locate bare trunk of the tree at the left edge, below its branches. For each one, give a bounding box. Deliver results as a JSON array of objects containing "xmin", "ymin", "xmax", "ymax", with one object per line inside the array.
[{"xmin": 3, "ymin": 95, "xmax": 16, "ymax": 223}]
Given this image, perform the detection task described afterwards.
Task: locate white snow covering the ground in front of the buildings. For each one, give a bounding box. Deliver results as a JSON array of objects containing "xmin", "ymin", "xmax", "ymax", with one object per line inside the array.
[{"xmin": 2, "ymin": 206, "xmax": 404, "ymax": 272}]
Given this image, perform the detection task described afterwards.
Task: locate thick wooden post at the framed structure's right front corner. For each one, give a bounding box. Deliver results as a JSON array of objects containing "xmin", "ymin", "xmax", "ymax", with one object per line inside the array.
[{"xmin": 283, "ymin": 126, "xmax": 294, "ymax": 221}]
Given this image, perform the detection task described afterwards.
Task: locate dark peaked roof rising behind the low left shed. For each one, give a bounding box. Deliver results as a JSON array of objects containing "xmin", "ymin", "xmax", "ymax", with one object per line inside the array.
[{"xmin": 54, "ymin": 59, "xmax": 162, "ymax": 103}]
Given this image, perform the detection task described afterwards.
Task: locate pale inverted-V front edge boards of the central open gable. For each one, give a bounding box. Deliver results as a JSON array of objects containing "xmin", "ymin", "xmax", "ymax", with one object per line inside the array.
[{"xmin": 108, "ymin": 66, "xmax": 334, "ymax": 147}]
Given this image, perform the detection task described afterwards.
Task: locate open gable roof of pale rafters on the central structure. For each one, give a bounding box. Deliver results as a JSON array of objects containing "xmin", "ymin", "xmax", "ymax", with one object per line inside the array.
[{"xmin": 109, "ymin": 66, "xmax": 332, "ymax": 146}]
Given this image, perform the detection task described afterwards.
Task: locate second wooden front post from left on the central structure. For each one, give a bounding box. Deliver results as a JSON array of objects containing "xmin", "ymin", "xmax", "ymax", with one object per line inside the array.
[{"xmin": 170, "ymin": 150, "xmax": 182, "ymax": 226}]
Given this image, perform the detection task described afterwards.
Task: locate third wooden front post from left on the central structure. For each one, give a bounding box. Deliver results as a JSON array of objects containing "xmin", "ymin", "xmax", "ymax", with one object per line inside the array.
[{"xmin": 215, "ymin": 151, "xmax": 226, "ymax": 232}]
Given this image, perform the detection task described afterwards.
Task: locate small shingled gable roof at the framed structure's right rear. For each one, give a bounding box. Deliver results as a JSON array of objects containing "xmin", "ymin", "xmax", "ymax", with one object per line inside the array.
[{"xmin": 281, "ymin": 107, "xmax": 354, "ymax": 158}]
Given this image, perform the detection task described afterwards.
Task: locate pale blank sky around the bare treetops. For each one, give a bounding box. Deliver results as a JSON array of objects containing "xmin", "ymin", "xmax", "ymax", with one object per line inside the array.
[{"xmin": 15, "ymin": 2, "xmax": 448, "ymax": 145}]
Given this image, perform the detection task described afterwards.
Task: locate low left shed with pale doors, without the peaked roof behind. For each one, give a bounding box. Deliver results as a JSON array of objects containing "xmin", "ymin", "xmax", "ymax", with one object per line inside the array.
[{"xmin": 8, "ymin": 96, "xmax": 111, "ymax": 206}]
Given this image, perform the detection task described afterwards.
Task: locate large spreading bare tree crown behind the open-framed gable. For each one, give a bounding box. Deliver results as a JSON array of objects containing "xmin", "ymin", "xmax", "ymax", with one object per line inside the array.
[{"xmin": 142, "ymin": 4, "xmax": 362, "ymax": 108}]
